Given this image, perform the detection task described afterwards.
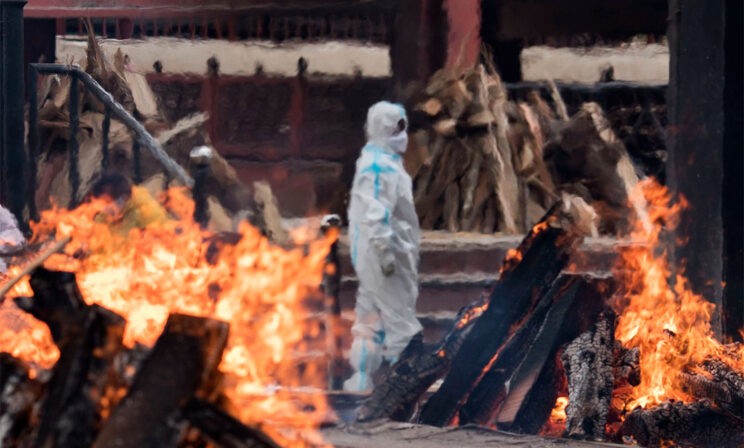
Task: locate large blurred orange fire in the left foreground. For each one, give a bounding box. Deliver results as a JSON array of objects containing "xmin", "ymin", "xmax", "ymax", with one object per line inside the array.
[{"xmin": 0, "ymin": 190, "xmax": 332, "ymax": 446}]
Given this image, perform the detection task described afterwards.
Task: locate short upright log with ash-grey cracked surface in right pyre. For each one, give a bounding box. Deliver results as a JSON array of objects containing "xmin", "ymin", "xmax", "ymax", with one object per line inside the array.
[{"xmin": 561, "ymin": 312, "xmax": 615, "ymax": 440}]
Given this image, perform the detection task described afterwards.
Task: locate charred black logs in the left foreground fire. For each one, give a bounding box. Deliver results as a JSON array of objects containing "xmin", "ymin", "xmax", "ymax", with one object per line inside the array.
[{"xmin": 0, "ymin": 268, "xmax": 278, "ymax": 448}]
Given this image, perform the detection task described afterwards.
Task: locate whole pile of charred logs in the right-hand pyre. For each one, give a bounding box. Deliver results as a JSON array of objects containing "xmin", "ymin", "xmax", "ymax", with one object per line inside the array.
[{"xmin": 358, "ymin": 191, "xmax": 744, "ymax": 447}]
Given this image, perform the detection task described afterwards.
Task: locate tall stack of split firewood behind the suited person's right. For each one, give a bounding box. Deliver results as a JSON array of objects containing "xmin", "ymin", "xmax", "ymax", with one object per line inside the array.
[{"xmin": 406, "ymin": 65, "xmax": 640, "ymax": 233}]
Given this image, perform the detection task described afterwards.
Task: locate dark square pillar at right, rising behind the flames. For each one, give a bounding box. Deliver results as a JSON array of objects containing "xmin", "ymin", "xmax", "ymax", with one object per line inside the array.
[{"xmin": 667, "ymin": 0, "xmax": 728, "ymax": 333}]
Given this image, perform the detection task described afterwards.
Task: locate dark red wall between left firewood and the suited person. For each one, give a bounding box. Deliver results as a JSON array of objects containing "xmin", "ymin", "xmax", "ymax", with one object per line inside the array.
[{"xmin": 148, "ymin": 73, "xmax": 390, "ymax": 216}]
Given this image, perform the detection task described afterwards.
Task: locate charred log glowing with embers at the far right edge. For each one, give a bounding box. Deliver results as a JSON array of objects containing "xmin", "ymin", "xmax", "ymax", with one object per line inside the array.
[{"xmin": 681, "ymin": 358, "xmax": 744, "ymax": 418}]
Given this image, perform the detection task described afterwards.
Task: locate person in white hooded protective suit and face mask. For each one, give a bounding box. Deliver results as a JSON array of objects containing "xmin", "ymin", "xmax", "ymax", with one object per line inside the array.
[{"xmin": 344, "ymin": 101, "xmax": 422, "ymax": 391}]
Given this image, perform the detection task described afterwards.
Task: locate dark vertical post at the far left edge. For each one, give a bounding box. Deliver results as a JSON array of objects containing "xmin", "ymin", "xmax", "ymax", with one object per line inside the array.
[{"xmin": 0, "ymin": 0, "xmax": 28, "ymax": 228}]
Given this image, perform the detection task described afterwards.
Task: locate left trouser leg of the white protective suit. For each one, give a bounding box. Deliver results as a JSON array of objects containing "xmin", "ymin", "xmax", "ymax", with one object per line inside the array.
[{"xmin": 344, "ymin": 284, "xmax": 385, "ymax": 391}]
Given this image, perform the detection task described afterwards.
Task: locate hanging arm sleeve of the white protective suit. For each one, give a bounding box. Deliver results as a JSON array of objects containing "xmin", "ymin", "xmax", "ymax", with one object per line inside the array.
[{"xmin": 357, "ymin": 164, "xmax": 397, "ymax": 260}]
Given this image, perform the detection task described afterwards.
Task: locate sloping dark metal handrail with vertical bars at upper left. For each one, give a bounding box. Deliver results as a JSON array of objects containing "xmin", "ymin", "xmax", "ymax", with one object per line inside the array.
[{"xmin": 27, "ymin": 64, "xmax": 195, "ymax": 219}]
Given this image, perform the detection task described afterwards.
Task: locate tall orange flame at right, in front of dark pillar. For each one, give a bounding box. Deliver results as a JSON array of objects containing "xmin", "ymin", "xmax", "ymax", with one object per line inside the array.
[{"xmin": 615, "ymin": 181, "xmax": 744, "ymax": 410}]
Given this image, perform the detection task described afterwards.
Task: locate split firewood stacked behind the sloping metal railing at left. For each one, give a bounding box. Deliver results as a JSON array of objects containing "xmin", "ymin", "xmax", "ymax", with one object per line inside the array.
[{"xmin": 35, "ymin": 26, "xmax": 286, "ymax": 239}]
